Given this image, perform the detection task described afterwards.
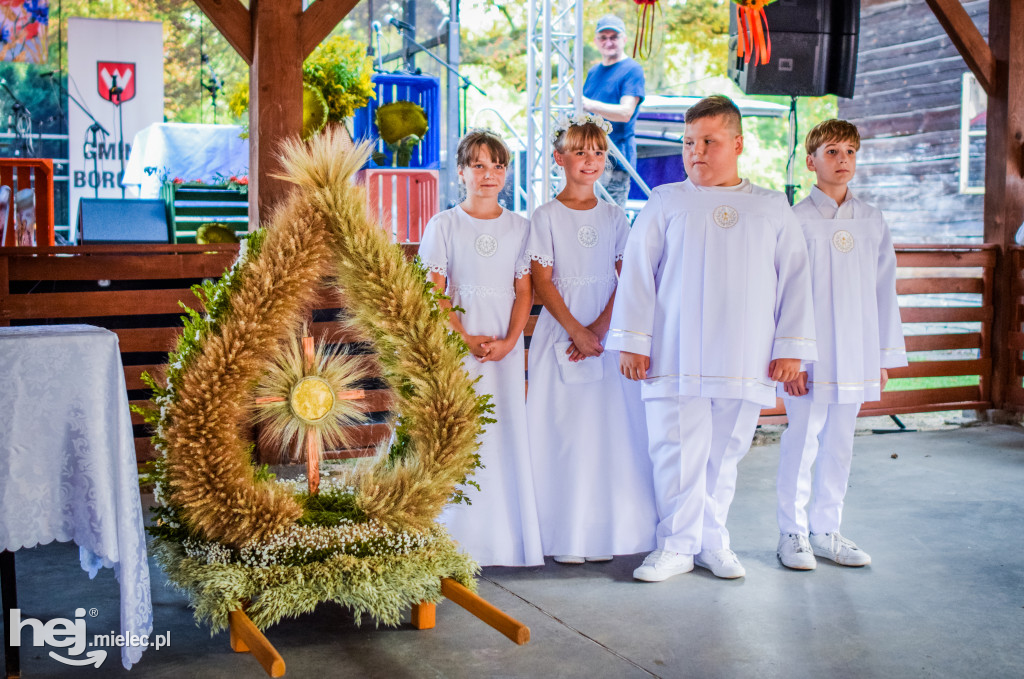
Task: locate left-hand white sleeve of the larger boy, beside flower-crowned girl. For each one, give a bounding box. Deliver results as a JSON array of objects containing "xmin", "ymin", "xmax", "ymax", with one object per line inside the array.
[{"xmin": 605, "ymin": 190, "xmax": 668, "ymax": 356}]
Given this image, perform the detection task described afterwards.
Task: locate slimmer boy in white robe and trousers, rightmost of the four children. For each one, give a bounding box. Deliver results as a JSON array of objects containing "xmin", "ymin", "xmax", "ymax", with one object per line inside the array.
[{"xmin": 777, "ymin": 120, "xmax": 906, "ymax": 570}]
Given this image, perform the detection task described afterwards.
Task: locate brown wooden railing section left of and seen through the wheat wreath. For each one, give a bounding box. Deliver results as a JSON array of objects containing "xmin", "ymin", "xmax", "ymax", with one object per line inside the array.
[{"xmin": 0, "ymin": 244, "xmax": 399, "ymax": 461}]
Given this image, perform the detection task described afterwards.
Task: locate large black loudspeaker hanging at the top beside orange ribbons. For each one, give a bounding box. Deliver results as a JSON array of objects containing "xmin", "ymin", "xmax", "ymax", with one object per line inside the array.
[{"xmin": 729, "ymin": 0, "xmax": 860, "ymax": 97}]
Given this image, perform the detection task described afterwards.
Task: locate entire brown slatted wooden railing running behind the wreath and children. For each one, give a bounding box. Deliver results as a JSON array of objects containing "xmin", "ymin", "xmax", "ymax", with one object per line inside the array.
[{"xmin": 0, "ymin": 245, "xmax": 1003, "ymax": 460}]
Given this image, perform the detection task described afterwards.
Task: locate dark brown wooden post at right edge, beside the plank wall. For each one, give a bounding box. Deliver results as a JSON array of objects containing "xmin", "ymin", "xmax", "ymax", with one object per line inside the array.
[{"xmin": 985, "ymin": 0, "xmax": 1024, "ymax": 409}]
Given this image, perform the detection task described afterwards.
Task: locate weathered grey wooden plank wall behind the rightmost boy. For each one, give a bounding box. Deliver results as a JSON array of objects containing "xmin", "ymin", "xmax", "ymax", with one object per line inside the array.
[{"xmin": 835, "ymin": 0, "xmax": 988, "ymax": 243}]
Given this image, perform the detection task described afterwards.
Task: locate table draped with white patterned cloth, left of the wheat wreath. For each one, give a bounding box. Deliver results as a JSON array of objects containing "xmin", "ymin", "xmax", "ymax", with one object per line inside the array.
[{"xmin": 0, "ymin": 325, "xmax": 153, "ymax": 669}]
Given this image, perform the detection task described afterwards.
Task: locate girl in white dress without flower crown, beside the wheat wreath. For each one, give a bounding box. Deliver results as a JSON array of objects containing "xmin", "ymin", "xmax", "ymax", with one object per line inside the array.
[{"xmin": 420, "ymin": 130, "xmax": 544, "ymax": 566}]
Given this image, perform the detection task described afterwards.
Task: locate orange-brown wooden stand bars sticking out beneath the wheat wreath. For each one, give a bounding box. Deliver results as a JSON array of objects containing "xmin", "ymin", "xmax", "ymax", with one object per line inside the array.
[{"xmin": 228, "ymin": 578, "xmax": 529, "ymax": 677}]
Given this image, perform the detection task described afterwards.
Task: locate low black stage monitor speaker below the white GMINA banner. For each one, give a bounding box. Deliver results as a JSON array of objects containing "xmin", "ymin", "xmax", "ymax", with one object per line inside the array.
[{"xmin": 78, "ymin": 198, "xmax": 172, "ymax": 245}]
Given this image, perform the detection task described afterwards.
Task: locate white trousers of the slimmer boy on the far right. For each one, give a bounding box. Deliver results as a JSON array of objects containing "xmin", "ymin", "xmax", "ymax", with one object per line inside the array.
[{"xmin": 776, "ymin": 397, "xmax": 860, "ymax": 536}]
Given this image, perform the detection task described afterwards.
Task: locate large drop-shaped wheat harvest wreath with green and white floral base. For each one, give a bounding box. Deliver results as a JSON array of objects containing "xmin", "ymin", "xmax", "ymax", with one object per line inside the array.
[{"xmin": 139, "ymin": 129, "xmax": 492, "ymax": 630}]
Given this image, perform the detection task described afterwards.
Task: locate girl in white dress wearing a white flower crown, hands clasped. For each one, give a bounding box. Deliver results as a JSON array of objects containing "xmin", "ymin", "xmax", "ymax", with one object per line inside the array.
[{"xmin": 526, "ymin": 115, "xmax": 657, "ymax": 563}]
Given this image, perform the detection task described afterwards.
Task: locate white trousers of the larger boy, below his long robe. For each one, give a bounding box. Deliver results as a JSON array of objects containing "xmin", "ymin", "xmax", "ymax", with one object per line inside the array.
[{"xmin": 644, "ymin": 396, "xmax": 761, "ymax": 554}]
